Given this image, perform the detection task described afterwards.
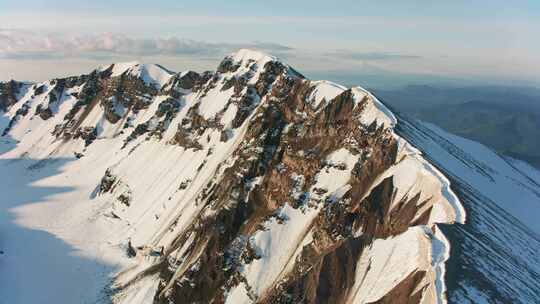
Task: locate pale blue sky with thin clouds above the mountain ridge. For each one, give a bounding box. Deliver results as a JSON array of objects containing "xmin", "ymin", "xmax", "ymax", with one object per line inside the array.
[{"xmin": 0, "ymin": 0, "xmax": 540, "ymax": 86}]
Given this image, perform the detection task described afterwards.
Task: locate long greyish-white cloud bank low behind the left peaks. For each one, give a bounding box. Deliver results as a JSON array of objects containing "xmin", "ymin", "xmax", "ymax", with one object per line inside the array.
[{"xmin": 0, "ymin": 29, "xmax": 292, "ymax": 59}]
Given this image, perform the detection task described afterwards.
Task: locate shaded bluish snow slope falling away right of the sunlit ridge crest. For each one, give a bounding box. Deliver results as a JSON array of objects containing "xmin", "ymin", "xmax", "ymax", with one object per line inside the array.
[{"xmin": 398, "ymin": 120, "xmax": 540, "ymax": 303}]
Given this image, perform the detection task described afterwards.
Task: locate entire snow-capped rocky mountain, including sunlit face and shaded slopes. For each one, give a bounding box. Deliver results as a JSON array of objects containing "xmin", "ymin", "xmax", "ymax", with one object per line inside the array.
[{"xmin": 0, "ymin": 50, "xmax": 540, "ymax": 303}]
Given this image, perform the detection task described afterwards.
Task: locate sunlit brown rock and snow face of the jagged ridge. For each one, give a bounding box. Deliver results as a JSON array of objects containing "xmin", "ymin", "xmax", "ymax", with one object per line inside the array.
[{"xmin": 0, "ymin": 50, "xmax": 465, "ymax": 303}]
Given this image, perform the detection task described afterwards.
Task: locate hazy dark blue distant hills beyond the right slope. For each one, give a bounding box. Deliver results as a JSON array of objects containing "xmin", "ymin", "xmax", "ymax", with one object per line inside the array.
[{"xmin": 374, "ymin": 86, "xmax": 540, "ymax": 168}]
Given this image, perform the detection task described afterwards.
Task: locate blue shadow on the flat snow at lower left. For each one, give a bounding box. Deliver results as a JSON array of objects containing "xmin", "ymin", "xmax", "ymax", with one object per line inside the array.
[{"xmin": 0, "ymin": 152, "xmax": 114, "ymax": 304}]
